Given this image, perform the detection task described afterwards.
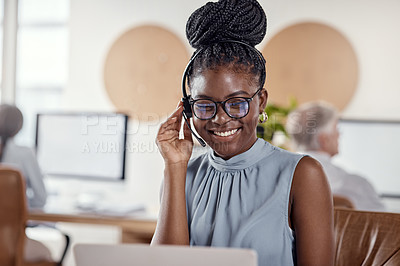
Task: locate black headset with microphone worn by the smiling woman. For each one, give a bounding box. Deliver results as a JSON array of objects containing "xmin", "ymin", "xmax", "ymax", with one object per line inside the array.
[{"xmin": 182, "ymin": 40, "xmax": 266, "ymax": 147}]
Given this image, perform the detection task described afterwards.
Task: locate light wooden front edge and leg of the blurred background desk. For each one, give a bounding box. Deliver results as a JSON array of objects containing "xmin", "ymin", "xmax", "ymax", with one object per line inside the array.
[{"xmin": 28, "ymin": 210, "xmax": 156, "ymax": 243}]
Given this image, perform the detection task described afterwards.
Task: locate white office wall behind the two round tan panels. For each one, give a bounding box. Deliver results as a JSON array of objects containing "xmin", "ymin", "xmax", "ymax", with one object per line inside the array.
[{"xmin": 63, "ymin": 0, "xmax": 400, "ymax": 206}]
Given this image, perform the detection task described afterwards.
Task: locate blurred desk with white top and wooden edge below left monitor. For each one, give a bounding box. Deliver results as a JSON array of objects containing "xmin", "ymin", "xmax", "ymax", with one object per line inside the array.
[{"xmin": 27, "ymin": 178, "xmax": 158, "ymax": 243}]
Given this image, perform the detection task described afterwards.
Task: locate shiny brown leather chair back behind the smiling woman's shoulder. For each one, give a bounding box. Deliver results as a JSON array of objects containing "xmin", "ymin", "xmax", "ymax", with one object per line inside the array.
[{"xmin": 334, "ymin": 209, "xmax": 400, "ymax": 266}]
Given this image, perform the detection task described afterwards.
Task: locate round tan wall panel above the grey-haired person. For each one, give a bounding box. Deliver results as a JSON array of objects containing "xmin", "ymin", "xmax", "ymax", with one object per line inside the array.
[{"xmin": 262, "ymin": 22, "xmax": 358, "ymax": 110}]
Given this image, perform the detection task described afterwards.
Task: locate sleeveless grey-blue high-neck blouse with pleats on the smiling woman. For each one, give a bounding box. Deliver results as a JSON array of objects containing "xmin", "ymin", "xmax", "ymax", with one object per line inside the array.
[{"xmin": 186, "ymin": 139, "xmax": 304, "ymax": 266}]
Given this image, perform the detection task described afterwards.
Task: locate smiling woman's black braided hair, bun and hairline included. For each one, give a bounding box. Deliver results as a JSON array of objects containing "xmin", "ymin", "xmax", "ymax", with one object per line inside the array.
[{"xmin": 186, "ymin": 0, "xmax": 267, "ymax": 87}]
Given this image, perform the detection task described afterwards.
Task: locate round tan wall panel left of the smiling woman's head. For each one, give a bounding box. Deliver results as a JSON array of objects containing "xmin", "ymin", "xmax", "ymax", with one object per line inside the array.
[{"xmin": 104, "ymin": 25, "xmax": 189, "ymax": 121}]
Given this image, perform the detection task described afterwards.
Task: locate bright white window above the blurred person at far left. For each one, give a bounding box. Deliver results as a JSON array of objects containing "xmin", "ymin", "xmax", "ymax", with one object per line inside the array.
[{"xmin": 15, "ymin": 0, "xmax": 69, "ymax": 146}]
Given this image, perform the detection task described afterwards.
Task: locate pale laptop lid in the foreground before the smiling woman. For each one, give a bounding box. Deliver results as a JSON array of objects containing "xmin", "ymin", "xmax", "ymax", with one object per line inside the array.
[{"xmin": 73, "ymin": 244, "xmax": 257, "ymax": 266}]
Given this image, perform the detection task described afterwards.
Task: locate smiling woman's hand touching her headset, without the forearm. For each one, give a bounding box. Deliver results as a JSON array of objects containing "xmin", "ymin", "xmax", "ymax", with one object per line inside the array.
[{"xmin": 156, "ymin": 102, "xmax": 193, "ymax": 164}]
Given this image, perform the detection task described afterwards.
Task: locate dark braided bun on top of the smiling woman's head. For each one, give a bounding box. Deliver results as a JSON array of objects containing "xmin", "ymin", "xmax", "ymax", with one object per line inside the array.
[{"xmin": 186, "ymin": 0, "xmax": 267, "ymax": 49}]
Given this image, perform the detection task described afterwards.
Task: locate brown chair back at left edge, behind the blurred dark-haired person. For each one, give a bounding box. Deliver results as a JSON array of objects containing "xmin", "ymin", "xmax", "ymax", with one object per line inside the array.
[{"xmin": 0, "ymin": 165, "xmax": 27, "ymax": 266}]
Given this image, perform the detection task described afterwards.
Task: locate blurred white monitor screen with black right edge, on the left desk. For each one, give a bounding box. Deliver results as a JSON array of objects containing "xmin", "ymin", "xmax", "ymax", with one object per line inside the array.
[{"xmin": 36, "ymin": 113, "xmax": 128, "ymax": 180}]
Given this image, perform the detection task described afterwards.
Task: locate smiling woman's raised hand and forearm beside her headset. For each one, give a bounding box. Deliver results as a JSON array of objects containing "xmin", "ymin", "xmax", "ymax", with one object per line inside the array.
[{"xmin": 151, "ymin": 102, "xmax": 193, "ymax": 245}]
